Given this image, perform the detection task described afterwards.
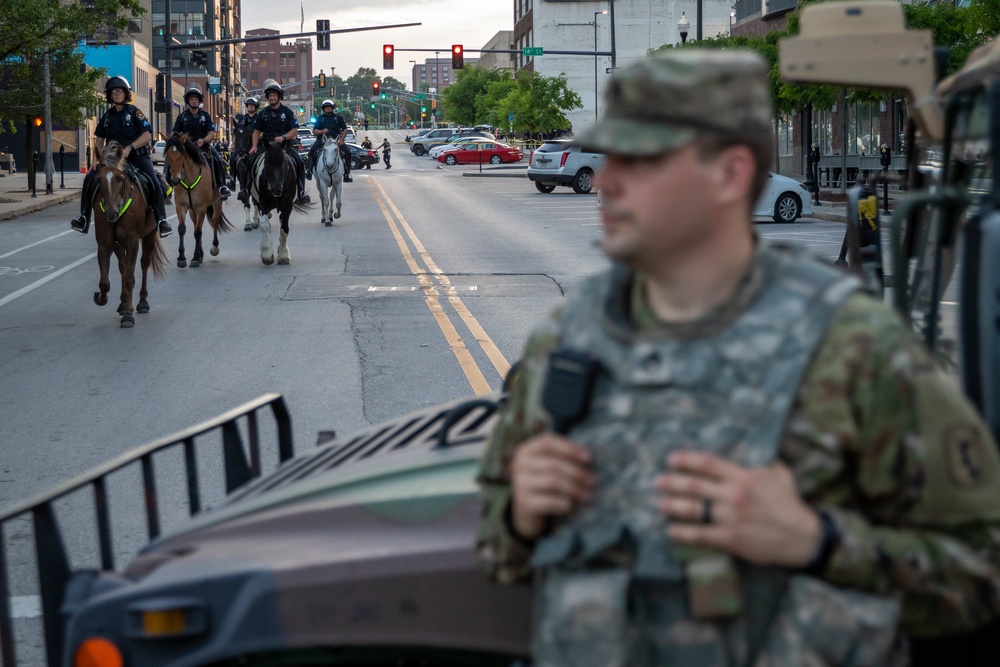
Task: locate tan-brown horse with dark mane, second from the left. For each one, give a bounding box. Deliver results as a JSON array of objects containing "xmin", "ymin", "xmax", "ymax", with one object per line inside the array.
[{"xmin": 164, "ymin": 134, "xmax": 233, "ymax": 269}]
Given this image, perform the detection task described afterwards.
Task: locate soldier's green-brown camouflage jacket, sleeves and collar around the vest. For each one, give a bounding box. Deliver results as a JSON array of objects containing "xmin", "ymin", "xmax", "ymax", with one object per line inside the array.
[{"xmin": 477, "ymin": 244, "xmax": 1000, "ymax": 636}]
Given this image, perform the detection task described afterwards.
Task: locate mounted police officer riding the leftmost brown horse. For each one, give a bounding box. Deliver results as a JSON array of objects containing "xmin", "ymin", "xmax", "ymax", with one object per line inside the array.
[{"xmin": 70, "ymin": 76, "xmax": 173, "ymax": 237}]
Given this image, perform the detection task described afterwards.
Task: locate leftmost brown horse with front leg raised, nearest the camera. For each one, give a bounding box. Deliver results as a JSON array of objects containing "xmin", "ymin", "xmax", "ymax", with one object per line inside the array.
[{"xmin": 94, "ymin": 141, "xmax": 167, "ymax": 328}]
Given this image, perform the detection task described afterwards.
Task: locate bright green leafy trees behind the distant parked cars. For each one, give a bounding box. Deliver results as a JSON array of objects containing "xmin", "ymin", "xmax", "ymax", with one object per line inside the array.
[{"xmin": 444, "ymin": 67, "xmax": 583, "ymax": 132}]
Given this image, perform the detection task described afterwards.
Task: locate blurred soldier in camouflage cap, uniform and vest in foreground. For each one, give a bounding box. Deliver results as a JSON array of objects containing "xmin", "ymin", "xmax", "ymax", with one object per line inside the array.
[{"xmin": 477, "ymin": 49, "xmax": 1000, "ymax": 667}]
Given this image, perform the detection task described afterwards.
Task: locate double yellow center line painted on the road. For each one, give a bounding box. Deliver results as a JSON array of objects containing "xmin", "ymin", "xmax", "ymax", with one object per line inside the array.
[{"xmin": 367, "ymin": 178, "xmax": 510, "ymax": 394}]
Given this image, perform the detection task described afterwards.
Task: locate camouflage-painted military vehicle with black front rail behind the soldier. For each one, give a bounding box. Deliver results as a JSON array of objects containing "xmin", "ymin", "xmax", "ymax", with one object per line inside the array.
[{"xmin": 0, "ymin": 0, "xmax": 1000, "ymax": 667}]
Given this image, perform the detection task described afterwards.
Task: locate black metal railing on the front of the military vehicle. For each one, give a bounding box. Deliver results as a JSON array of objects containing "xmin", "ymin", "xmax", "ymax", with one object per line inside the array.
[{"xmin": 0, "ymin": 393, "xmax": 294, "ymax": 667}]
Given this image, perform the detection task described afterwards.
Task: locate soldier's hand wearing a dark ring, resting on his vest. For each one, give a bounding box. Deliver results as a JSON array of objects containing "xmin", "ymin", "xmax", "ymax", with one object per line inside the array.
[{"xmin": 656, "ymin": 451, "xmax": 821, "ymax": 567}]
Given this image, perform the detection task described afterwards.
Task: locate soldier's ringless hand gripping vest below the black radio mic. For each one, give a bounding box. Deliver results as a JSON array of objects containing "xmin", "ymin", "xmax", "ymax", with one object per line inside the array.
[{"xmin": 510, "ymin": 433, "xmax": 596, "ymax": 539}]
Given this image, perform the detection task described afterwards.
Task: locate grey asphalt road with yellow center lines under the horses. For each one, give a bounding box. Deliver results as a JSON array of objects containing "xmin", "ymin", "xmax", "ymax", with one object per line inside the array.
[{"xmin": 0, "ymin": 144, "xmax": 860, "ymax": 664}]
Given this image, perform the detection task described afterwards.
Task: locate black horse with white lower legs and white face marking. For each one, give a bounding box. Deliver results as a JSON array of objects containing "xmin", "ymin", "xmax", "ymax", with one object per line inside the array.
[{"xmin": 248, "ymin": 141, "xmax": 309, "ymax": 266}]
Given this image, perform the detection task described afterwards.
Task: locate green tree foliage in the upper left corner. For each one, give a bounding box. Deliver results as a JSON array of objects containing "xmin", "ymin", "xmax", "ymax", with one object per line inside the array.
[{"xmin": 0, "ymin": 0, "xmax": 143, "ymax": 131}]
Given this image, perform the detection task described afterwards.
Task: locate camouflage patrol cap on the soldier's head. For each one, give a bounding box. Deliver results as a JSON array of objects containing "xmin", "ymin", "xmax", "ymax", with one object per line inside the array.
[{"xmin": 574, "ymin": 48, "xmax": 773, "ymax": 155}]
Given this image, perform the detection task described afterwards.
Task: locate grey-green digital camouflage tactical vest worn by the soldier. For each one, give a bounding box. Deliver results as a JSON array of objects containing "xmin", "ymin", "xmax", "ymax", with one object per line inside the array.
[{"xmin": 532, "ymin": 244, "xmax": 898, "ymax": 667}]
